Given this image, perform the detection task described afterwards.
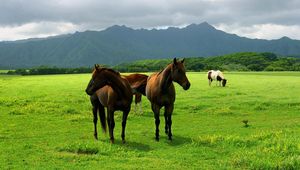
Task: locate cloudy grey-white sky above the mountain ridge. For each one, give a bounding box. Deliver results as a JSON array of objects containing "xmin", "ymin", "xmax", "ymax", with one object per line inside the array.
[{"xmin": 0, "ymin": 0, "xmax": 300, "ymax": 41}]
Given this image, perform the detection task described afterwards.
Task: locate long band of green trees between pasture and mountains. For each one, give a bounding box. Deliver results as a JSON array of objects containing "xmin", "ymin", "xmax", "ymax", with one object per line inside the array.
[{"xmin": 7, "ymin": 52, "xmax": 300, "ymax": 75}]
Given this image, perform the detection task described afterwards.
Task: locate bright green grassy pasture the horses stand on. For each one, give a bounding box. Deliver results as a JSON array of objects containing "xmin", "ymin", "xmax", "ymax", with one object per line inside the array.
[{"xmin": 0, "ymin": 72, "xmax": 300, "ymax": 169}]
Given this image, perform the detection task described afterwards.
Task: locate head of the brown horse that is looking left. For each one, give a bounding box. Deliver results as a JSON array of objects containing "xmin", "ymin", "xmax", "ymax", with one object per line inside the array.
[{"xmin": 85, "ymin": 64, "xmax": 107, "ymax": 95}]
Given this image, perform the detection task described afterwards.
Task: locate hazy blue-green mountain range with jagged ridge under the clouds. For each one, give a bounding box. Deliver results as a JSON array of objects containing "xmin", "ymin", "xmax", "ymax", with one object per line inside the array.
[{"xmin": 0, "ymin": 22, "xmax": 300, "ymax": 69}]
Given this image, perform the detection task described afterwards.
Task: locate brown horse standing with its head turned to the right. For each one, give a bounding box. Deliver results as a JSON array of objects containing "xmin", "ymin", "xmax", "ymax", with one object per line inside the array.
[{"xmin": 146, "ymin": 58, "xmax": 191, "ymax": 141}]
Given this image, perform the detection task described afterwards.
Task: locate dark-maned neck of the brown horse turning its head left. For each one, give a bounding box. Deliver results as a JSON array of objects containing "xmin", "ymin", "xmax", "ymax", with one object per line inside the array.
[{"xmin": 106, "ymin": 71, "xmax": 131, "ymax": 97}]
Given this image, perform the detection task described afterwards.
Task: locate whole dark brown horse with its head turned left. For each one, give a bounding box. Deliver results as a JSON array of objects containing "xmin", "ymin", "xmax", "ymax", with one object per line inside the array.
[{"xmin": 86, "ymin": 65, "xmax": 132, "ymax": 143}]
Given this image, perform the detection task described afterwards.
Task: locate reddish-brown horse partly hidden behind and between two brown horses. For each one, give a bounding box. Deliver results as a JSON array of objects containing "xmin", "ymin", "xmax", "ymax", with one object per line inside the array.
[{"xmin": 123, "ymin": 73, "xmax": 148, "ymax": 113}]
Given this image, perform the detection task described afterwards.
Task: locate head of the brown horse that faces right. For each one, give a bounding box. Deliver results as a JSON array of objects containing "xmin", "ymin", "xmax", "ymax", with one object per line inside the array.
[{"xmin": 171, "ymin": 58, "xmax": 191, "ymax": 90}]
